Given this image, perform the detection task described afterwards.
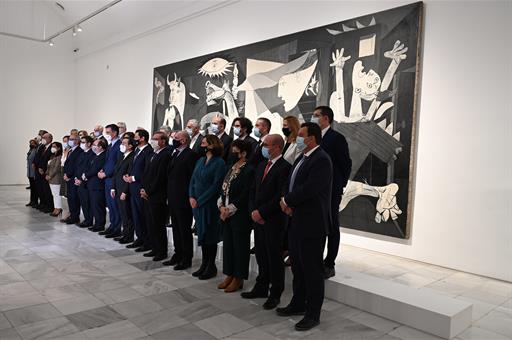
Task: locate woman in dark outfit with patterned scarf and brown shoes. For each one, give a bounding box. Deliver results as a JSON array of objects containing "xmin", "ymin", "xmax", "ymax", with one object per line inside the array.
[{"xmin": 217, "ymin": 139, "xmax": 254, "ymax": 293}]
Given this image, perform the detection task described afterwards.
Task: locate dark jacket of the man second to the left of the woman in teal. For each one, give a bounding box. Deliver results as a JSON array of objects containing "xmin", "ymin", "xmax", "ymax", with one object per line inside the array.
[{"xmin": 141, "ymin": 146, "xmax": 171, "ymax": 203}]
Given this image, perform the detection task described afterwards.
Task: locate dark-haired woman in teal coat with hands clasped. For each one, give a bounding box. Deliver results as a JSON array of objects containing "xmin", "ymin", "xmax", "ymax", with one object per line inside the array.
[{"xmin": 189, "ymin": 135, "xmax": 226, "ymax": 280}]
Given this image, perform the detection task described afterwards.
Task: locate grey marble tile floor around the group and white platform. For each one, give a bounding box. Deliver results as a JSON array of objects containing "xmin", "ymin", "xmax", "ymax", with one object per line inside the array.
[{"xmin": 0, "ymin": 186, "xmax": 512, "ymax": 340}]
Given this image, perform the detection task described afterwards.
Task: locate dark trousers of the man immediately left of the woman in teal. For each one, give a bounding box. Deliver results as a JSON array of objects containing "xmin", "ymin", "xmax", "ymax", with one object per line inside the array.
[{"xmin": 169, "ymin": 205, "xmax": 194, "ymax": 264}]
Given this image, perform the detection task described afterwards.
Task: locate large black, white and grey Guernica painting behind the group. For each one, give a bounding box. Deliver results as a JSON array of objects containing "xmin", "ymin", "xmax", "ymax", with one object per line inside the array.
[{"xmin": 152, "ymin": 2, "xmax": 422, "ymax": 238}]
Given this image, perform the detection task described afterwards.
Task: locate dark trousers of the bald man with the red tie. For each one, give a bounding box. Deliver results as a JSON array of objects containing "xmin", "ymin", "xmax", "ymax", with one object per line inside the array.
[{"xmin": 254, "ymin": 224, "xmax": 286, "ymax": 299}]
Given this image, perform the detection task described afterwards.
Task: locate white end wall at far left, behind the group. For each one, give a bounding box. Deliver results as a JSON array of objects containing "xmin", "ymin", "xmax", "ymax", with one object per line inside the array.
[{"xmin": 0, "ymin": 36, "xmax": 75, "ymax": 186}]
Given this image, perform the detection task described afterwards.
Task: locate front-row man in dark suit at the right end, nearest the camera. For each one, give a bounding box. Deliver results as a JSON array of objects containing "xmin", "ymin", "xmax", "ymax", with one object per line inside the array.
[{"xmin": 277, "ymin": 123, "xmax": 332, "ymax": 331}]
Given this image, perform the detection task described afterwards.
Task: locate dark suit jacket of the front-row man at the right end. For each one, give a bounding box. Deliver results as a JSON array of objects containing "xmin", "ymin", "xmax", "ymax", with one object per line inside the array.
[{"xmin": 284, "ymin": 147, "xmax": 332, "ymax": 239}]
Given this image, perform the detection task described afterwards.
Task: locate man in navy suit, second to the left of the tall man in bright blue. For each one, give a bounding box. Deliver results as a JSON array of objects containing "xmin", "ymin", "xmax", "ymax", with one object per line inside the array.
[{"xmin": 74, "ymin": 135, "xmax": 96, "ymax": 228}]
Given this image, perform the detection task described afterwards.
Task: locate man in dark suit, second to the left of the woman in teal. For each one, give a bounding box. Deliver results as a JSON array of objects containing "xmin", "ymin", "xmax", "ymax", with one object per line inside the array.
[{"xmin": 140, "ymin": 131, "xmax": 171, "ymax": 261}]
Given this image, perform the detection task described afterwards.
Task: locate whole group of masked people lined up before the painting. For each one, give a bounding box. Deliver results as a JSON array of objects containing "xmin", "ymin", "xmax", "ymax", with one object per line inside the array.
[{"xmin": 27, "ymin": 106, "xmax": 351, "ymax": 330}]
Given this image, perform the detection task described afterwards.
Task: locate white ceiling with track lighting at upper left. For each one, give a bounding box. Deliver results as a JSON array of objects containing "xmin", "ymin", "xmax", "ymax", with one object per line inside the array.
[{"xmin": 0, "ymin": 0, "xmax": 239, "ymax": 53}]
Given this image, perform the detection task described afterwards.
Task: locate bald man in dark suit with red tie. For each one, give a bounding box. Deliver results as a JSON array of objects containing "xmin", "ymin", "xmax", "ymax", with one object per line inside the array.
[{"xmin": 242, "ymin": 135, "xmax": 291, "ymax": 309}]
